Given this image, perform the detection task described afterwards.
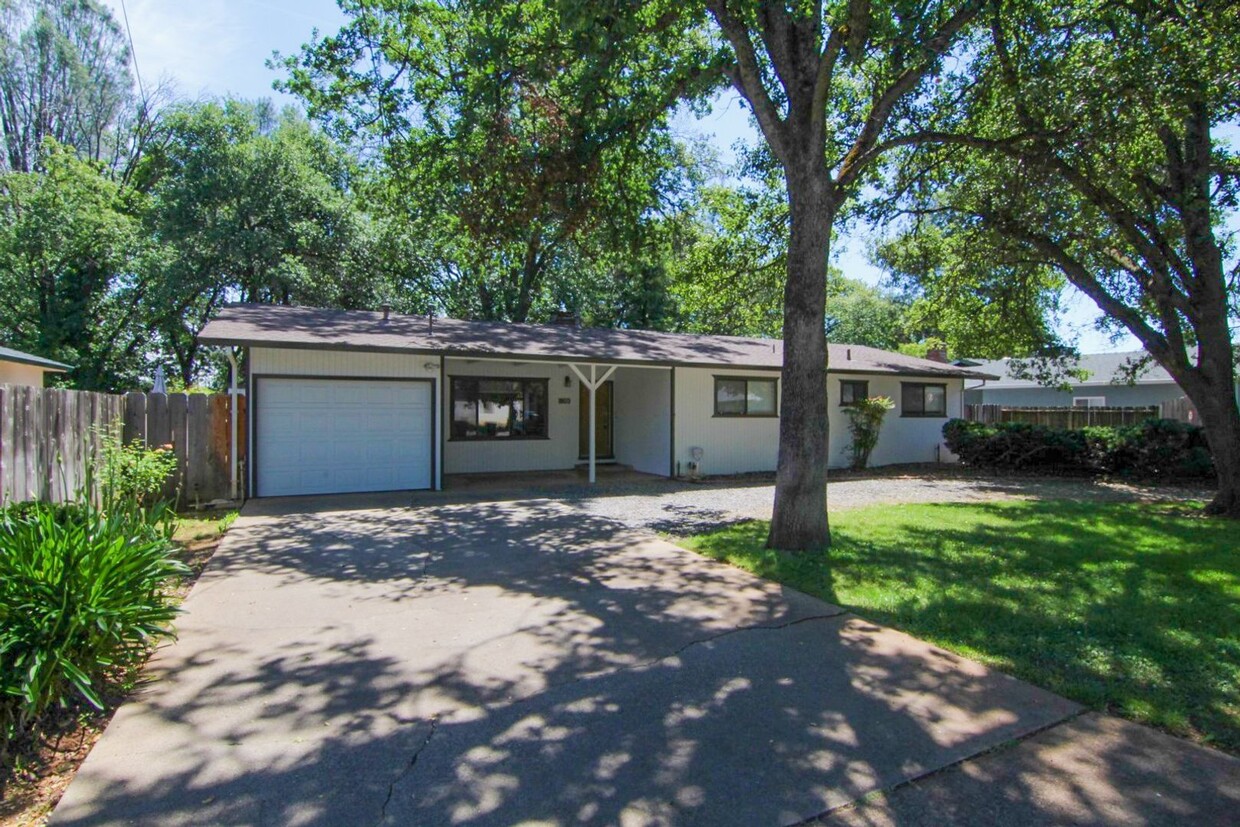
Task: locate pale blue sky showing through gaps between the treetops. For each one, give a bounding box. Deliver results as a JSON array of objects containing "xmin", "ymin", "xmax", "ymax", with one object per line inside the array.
[{"xmin": 103, "ymin": 0, "xmax": 1136, "ymax": 352}]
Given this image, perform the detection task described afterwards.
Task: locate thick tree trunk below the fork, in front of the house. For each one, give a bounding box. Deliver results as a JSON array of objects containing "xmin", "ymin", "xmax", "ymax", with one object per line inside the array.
[{"xmin": 766, "ymin": 164, "xmax": 836, "ymax": 552}]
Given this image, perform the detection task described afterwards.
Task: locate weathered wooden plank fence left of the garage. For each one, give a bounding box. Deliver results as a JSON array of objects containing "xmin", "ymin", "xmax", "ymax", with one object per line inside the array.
[{"xmin": 0, "ymin": 384, "xmax": 246, "ymax": 506}]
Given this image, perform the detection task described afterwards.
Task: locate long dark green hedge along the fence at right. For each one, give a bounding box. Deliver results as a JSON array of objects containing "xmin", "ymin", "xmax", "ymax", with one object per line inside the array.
[{"xmin": 942, "ymin": 419, "xmax": 1214, "ymax": 479}]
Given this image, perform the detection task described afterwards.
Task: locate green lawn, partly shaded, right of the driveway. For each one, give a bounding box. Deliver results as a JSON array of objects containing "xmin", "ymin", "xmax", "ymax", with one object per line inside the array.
[{"xmin": 683, "ymin": 501, "xmax": 1240, "ymax": 754}]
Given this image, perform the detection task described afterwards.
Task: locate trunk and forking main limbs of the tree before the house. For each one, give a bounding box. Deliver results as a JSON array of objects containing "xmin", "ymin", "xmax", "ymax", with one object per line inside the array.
[{"xmin": 706, "ymin": 0, "xmax": 982, "ymax": 549}]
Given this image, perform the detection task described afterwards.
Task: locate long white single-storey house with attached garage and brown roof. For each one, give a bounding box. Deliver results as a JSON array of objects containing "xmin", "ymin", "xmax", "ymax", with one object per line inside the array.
[{"xmin": 198, "ymin": 305, "xmax": 993, "ymax": 496}]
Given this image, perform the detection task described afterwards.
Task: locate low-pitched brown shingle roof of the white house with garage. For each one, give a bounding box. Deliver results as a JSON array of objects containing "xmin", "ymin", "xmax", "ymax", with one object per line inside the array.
[{"xmin": 198, "ymin": 304, "xmax": 994, "ymax": 379}]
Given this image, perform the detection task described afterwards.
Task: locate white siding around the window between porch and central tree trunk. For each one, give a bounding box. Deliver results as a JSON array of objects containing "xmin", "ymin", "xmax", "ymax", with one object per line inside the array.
[{"xmin": 675, "ymin": 367, "xmax": 784, "ymax": 475}]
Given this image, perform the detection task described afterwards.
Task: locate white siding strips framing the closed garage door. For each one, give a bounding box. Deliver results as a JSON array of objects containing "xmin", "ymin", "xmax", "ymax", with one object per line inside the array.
[{"xmin": 247, "ymin": 347, "xmax": 444, "ymax": 491}]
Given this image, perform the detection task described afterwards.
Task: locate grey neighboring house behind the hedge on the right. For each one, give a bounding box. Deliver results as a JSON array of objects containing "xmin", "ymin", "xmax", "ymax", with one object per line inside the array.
[{"xmin": 956, "ymin": 351, "xmax": 1184, "ymax": 408}]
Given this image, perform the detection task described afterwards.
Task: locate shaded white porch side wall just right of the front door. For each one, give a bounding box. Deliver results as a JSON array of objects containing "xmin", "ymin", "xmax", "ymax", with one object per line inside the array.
[{"xmin": 613, "ymin": 367, "xmax": 672, "ymax": 476}]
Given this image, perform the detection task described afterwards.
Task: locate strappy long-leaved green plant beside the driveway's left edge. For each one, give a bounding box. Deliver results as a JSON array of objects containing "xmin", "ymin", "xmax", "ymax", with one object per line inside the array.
[{"xmin": 0, "ymin": 505, "xmax": 188, "ymax": 751}]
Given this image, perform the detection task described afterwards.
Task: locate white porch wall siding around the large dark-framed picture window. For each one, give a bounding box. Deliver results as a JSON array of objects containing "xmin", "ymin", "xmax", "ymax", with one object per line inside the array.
[{"xmin": 443, "ymin": 358, "xmax": 578, "ymax": 474}]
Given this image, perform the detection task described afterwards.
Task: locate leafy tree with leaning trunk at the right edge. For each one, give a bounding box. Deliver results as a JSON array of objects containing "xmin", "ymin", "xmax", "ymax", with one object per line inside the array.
[{"xmin": 900, "ymin": 0, "xmax": 1240, "ymax": 517}]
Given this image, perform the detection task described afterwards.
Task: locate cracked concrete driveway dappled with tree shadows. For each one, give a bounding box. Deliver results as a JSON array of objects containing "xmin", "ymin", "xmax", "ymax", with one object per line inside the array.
[{"xmin": 52, "ymin": 497, "xmax": 1240, "ymax": 825}]
